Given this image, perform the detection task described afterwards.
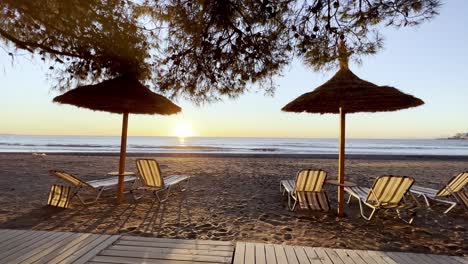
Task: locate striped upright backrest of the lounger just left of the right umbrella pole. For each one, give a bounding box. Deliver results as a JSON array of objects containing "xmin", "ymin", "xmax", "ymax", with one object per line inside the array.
[{"xmin": 294, "ymin": 169, "xmax": 327, "ymax": 192}]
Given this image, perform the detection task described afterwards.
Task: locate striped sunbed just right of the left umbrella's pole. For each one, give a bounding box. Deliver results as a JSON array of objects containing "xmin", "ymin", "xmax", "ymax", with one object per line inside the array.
[{"xmin": 131, "ymin": 159, "xmax": 190, "ymax": 202}]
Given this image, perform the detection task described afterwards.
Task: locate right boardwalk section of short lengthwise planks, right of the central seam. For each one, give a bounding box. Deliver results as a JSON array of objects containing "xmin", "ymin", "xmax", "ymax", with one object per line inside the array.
[{"xmin": 233, "ymin": 242, "xmax": 468, "ymax": 264}]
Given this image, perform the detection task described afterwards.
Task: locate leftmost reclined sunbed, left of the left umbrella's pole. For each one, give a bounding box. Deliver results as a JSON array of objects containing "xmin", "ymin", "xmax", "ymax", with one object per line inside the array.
[{"xmin": 49, "ymin": 170, "xmax": 136, "ymax": 205}]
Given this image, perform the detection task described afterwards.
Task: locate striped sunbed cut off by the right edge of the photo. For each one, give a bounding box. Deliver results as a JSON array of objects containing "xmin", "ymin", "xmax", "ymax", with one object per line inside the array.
[{"xmin": 410, "ymin": 171, "xmax": 468, "ymax": 214}]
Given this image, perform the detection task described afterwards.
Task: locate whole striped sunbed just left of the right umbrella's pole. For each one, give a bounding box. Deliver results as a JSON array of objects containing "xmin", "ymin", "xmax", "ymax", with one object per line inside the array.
[{"xmin": 280, "ymin": 169, "xmax": 330, "ymax": 211}]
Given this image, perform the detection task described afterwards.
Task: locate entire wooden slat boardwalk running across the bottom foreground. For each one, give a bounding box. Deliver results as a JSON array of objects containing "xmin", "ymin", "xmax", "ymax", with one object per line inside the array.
[{"xmin": 0, "ymin": 229, "xmax": 468, "ymax": 264}]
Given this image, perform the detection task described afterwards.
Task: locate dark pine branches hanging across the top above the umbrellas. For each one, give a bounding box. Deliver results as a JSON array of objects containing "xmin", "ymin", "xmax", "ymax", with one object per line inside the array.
[{"xmin": 0, "ymin": 0, "xmax": 440, "ymax": 102}]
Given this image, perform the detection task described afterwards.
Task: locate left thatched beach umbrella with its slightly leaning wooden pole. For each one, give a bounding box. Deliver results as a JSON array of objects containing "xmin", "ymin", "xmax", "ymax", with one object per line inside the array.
[{"xmin": 54, "ymin": 75, "xmax": 181, "ymax": 203}]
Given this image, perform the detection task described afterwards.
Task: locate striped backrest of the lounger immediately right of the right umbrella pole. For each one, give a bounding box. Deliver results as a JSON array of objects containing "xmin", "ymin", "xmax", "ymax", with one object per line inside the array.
[{"xmin": 366, "ymin": 176, "xmax": 414, "ymax": 208}]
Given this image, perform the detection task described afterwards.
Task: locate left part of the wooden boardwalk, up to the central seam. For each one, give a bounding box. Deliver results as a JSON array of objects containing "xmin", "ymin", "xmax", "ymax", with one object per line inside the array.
[{"xmin": 0, "ymin": 229, "xmax": 234, "ymax": 264}]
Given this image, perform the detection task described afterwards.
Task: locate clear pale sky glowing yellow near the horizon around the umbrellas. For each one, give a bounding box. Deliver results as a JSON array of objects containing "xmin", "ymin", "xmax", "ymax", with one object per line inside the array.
[{"xmin": 0, "ymin": 0, "xmax": 468, "ymax": 138}]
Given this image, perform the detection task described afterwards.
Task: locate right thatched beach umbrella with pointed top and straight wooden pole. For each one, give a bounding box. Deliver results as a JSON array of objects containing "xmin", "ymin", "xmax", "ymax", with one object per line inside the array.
[{"xmin": 281, "ymin": 45, "xmax": 424, "ymax": 216}]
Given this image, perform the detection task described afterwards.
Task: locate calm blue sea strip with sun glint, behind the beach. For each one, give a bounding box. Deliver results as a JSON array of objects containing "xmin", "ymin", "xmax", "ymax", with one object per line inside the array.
[{"xmin": 0, "ymin": 135, "xmax": 468, "ymax": 156}]
